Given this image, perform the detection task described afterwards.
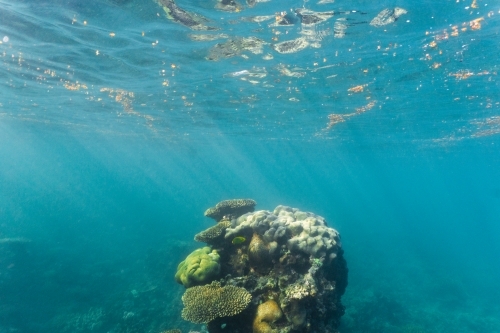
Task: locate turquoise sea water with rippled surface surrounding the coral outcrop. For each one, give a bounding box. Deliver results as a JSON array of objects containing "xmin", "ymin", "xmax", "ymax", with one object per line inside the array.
[{"xmin": 0, "ymin": 0, "xmax": 500, "ymax": 333}]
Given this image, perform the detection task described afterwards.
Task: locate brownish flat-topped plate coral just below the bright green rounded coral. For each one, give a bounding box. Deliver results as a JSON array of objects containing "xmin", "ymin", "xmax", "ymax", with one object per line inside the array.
[{"xmin": 182, "ymin": 281, "xmax": 252, "ymax": 324}]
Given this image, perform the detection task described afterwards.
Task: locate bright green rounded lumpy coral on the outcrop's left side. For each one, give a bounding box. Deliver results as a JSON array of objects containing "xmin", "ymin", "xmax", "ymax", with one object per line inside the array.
[{"xmin": 175, "ymin": 246, "xmax": 220, "ymax": 288}]
